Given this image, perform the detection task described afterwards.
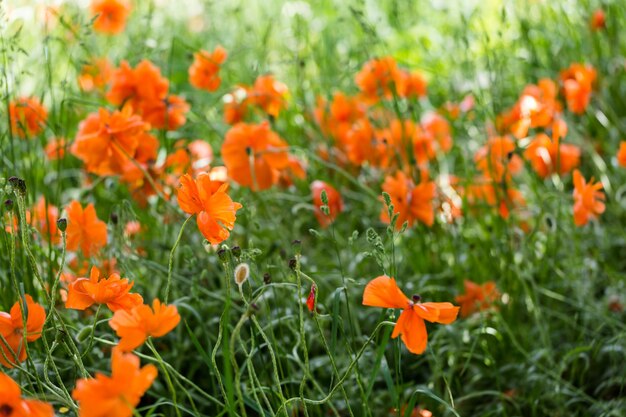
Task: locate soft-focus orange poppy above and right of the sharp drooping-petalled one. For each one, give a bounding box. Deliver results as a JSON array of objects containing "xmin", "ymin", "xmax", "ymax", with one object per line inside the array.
[{"xmin": 380, "ymin": 171, "xmax": 436, "ymax": 229}]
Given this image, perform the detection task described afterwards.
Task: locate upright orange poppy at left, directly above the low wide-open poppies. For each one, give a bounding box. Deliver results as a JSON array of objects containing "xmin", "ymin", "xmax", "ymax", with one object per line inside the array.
[{"xmin": 66, "ymin": 200, "xmax": 107, "ymax": 258}]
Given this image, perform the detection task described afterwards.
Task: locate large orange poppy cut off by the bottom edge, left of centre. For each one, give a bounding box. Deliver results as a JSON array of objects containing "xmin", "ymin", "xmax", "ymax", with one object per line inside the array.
[{"xmin": 72, "ymin": 349, "xmax": 158, "ymax": 417}]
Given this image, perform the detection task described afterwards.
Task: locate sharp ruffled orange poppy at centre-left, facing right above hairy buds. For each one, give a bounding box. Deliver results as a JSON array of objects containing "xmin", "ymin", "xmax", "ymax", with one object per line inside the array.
[{"xmin": 178, "ymin": 173, "xmax": 242, "ymax": 245}]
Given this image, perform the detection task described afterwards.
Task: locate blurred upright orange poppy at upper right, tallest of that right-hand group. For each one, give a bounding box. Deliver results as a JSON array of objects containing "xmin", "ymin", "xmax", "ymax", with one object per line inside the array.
[{"xmin": 561, "ymin": 63, "xmax": 596, "ymax": 114}]
